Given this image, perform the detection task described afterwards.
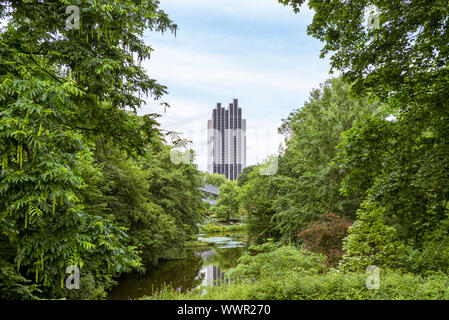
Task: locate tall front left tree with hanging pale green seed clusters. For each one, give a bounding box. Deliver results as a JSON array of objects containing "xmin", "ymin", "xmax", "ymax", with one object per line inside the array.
[{"xmin": 0, "ymin": 0, "xmax": 176, "ymax": 296}]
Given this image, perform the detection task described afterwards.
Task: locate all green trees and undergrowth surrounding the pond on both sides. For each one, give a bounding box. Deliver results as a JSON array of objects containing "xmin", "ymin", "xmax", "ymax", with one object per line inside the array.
[{"xmin": 0, "ymin": 0, "xmax": 449, "ymax": 299}]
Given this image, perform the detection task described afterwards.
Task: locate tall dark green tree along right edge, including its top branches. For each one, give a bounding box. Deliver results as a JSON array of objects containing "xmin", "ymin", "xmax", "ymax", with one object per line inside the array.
[{"xmin": 280, "ymin": 0, "xmax": 449, "ymax": 247}]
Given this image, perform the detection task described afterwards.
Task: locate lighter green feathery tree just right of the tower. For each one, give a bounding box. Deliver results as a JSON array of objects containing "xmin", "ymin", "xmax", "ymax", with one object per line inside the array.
[{"xmin": 242, "ymin": 79, "xmax": 383, "ymax": 248}]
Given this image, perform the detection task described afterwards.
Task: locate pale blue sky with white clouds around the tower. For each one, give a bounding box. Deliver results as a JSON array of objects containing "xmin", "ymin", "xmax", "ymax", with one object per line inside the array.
[{"xmin": 140, "ymin": 0, "xmax": 331, "ymax": 170}]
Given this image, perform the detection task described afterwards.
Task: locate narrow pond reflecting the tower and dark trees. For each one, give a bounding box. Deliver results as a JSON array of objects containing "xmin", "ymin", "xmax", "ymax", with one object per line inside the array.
[{"xmin": 108, "ymin": 233, "xmax": 247, "ymax": 300}]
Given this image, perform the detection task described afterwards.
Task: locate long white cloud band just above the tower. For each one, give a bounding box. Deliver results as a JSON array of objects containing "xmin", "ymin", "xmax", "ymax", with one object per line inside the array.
[{"xmin": 143, "ymin": 46, "xmax": 313, "ymax": 93}]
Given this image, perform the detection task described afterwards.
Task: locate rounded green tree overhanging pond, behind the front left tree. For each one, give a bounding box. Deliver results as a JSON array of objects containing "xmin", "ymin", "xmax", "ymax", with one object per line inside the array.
[{"xmin": 85, "ymin": 146, "xmax": 202, "ymax": 263}]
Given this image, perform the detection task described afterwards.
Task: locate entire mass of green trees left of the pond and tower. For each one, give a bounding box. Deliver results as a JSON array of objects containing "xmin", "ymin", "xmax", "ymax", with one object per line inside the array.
[{"xmin": 0, "ymin": 0, "xmax": 202, "ymax": 299}]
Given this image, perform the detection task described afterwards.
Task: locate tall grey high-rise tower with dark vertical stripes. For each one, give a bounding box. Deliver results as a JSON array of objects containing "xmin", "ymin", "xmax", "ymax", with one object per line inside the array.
[{"xmin": 207, "ymin": 99, "xmax": 246, "ymax": 180}]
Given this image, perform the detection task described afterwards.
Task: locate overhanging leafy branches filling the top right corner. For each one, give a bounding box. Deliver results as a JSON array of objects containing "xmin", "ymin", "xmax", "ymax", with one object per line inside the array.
[{"xmin": 279, "ymin": 0, "xmax": 449, "ymax": 107}]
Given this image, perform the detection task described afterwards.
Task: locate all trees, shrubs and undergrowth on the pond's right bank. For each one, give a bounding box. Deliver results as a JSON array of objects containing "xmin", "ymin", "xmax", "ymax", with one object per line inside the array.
[{"xmin": 147, "ymin": 0, "xmax": 449, "ymax": 299}]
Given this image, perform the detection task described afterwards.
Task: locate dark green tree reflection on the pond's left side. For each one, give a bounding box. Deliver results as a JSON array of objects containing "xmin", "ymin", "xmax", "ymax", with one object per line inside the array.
[{"xmin": 109, "ymin": 254, "xmax": 203, "ymax": 299}]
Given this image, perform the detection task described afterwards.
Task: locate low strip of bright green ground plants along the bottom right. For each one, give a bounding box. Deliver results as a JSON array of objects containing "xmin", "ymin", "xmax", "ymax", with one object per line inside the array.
[{"xmin": 144, "ymin": 272, "xmax": 449, "ymax": 300}]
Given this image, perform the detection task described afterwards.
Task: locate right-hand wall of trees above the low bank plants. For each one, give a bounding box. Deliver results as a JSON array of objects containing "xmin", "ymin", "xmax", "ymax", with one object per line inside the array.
[{"xmin": 228, "ymin": 0, "xmax": 449, "ymax": 282}]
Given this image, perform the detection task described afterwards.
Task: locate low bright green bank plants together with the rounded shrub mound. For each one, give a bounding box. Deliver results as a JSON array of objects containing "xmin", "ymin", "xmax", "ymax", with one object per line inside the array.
[{"xmin": 143, "ymin": 244, "xmax": 449, "ymax": 300}]
